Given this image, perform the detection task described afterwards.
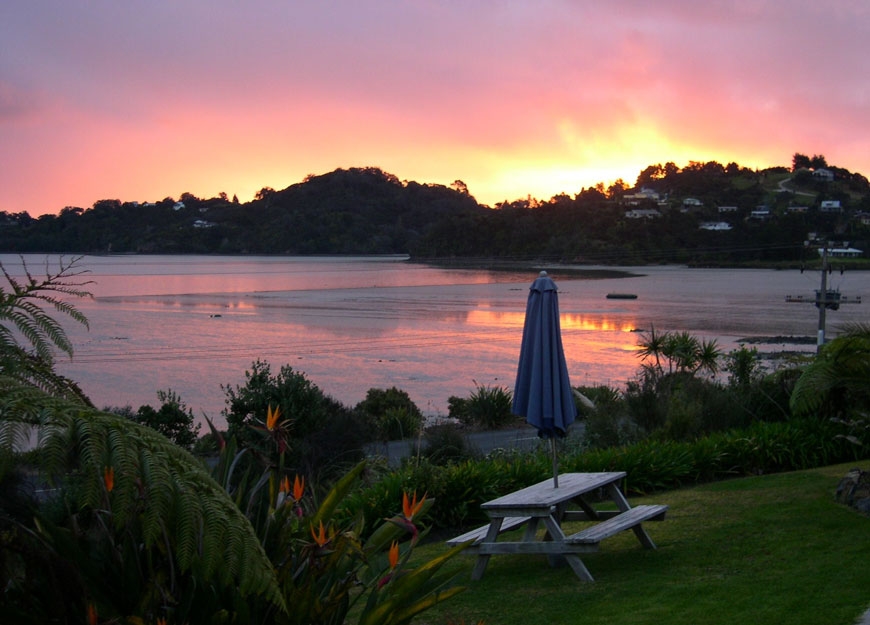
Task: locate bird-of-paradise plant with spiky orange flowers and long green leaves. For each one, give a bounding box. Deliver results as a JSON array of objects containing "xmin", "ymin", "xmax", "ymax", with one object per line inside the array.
[{"xmin": 207, "ymin": 428, "xmax": 470, "ymax": 625}]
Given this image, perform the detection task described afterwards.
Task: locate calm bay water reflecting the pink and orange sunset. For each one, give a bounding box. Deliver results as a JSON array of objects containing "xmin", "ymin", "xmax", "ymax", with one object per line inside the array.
[{"xmin": 0, "ymin": 255, "xmax": 870, "ymax": 422}]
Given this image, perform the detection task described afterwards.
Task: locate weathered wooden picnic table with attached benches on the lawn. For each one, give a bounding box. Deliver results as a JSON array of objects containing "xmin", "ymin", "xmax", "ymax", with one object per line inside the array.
[{"xmin": 447, "ymin": 471, "xmax": 668, "ymax": 582}]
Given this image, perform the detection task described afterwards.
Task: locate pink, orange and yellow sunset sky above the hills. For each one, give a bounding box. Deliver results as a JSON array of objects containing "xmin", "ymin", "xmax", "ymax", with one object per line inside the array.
[{"xmin": 0, "ymin": 0, "xmax": 870, "ymax": 216}]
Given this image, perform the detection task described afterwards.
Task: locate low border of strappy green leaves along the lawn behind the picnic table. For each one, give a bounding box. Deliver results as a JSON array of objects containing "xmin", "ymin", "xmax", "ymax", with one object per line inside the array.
[{"xmin": 349, "ymin": 419, "xmax": 870, "ymax": 528}]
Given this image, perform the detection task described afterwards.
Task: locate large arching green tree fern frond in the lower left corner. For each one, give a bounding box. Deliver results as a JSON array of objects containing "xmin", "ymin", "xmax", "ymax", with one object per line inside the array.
[{"xmin": 0, "ymin": 376, "xmax": 284, "ymax": 608}]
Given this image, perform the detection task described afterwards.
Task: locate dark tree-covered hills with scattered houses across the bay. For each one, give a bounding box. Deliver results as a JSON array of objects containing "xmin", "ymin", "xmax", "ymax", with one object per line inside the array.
[{"xmin": 0, "ymin": 154, "xmax": 870, "ymax": 263}]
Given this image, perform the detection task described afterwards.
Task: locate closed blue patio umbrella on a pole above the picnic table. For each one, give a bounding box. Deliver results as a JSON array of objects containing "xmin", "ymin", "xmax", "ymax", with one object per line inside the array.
[{"xmin": 512, "ymin": 271, "xmax": 577, "ymax": 488}]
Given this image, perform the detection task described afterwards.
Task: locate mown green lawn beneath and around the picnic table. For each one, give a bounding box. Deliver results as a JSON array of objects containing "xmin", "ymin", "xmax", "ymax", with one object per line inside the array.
[{"xmin": 414, "ymin": 463, "xmax": 870, "ymax": 625}]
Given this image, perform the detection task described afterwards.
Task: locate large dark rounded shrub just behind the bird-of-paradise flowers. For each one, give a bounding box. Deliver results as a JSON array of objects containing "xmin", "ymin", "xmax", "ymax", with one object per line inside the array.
[{"xmin": 222, "ymin": 360, "xmax": 368, "ymax": 479}]
